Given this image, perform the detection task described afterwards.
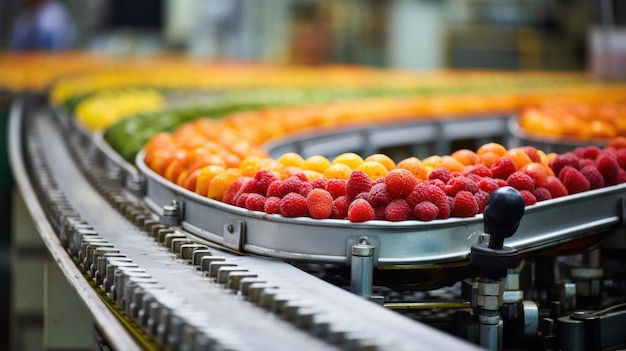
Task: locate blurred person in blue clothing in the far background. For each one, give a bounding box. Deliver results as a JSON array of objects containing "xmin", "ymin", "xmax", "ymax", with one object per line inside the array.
[{"xmin": 10, "ymin": 0, "xmax": 75, "ymax": 51}]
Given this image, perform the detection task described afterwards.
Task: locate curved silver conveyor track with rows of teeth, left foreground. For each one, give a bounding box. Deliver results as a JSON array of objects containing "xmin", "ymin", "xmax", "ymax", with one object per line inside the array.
[{"xmin": 11, "ymin": 95, "xmax": 476, "ymax": 350}]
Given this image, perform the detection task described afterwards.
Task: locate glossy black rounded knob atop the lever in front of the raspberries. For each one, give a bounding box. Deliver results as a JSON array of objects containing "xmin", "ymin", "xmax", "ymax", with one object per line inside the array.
[{"xmin": 484, "ymin": 186, "xmax": 525, "ymax": 249}]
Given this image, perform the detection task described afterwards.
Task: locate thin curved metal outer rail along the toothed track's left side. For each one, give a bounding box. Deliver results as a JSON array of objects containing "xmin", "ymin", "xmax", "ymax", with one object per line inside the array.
[{"xmin": 8, "ymin": 97, "xmax": 141, "ymax": 350}]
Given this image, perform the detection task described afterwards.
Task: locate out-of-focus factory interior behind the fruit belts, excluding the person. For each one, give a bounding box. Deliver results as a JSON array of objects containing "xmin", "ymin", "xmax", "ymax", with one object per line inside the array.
[{"xmin": 0, "ymin": 0, "xmax": 626, "ymax": 70}]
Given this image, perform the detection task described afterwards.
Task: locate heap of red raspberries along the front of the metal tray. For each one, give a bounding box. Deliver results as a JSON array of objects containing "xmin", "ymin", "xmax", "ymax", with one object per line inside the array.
[{"xmin": 218, "ymin": 145, "xmax": 626, "ymax": 222}]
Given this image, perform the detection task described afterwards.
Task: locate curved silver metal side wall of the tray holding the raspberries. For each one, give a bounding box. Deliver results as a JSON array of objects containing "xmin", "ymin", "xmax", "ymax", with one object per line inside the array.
[{"xmin": 136, "ymin": 152, "xmax": 626, "ymax": 266}]
